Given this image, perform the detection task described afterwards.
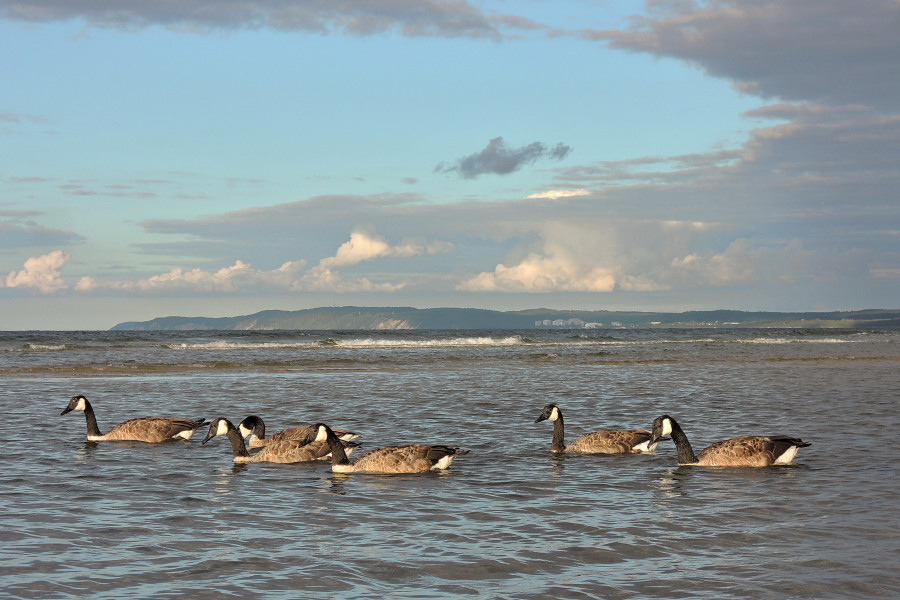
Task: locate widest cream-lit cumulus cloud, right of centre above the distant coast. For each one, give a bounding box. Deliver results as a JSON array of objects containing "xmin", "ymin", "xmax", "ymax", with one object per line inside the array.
[{"xmin": 457, "ymin": 221, "xmax": 799, "ymax": 293}]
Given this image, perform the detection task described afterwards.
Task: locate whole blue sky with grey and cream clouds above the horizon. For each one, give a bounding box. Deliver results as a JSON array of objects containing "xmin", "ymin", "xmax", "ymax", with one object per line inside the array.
[{"xmin": 0, "ymin": 0, "xmax": 900, "ymax": 330}]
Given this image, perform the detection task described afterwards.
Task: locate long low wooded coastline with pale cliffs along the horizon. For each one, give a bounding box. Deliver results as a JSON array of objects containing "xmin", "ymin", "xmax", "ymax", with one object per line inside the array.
[{"xmin": 110, "ymin": 306, "xmax": 900, "ymax": 331}]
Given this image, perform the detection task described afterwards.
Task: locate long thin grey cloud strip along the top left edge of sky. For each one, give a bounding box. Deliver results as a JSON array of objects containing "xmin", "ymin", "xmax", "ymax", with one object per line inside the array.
[{"xmin": 0, "ymin": 0, "xmax": 537, "ymax": 39}]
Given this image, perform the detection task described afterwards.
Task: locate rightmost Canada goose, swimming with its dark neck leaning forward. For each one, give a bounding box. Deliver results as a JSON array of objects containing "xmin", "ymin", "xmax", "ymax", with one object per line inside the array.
[{"xmin": 651, "ymin": 415, "xmax": 811, "ymax": 467}]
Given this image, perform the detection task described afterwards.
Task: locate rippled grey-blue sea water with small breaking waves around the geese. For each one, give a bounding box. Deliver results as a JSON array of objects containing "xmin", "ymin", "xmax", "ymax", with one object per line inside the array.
[{"xmin": 0, "ymin": 329, "xmax": 900, "ymax": 599}]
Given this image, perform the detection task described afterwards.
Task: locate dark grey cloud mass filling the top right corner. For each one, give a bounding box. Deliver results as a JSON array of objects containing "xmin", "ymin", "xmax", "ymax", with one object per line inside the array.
[{"xmin": 582, "ymin": 0, "xmax": 900, "ymax": 111}]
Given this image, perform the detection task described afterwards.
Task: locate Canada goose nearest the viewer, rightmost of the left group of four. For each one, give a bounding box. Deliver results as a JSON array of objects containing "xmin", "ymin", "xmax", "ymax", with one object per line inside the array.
[{"xmin": 315, "ymin": 423, "xmax": 469, "ymax": 474}]
